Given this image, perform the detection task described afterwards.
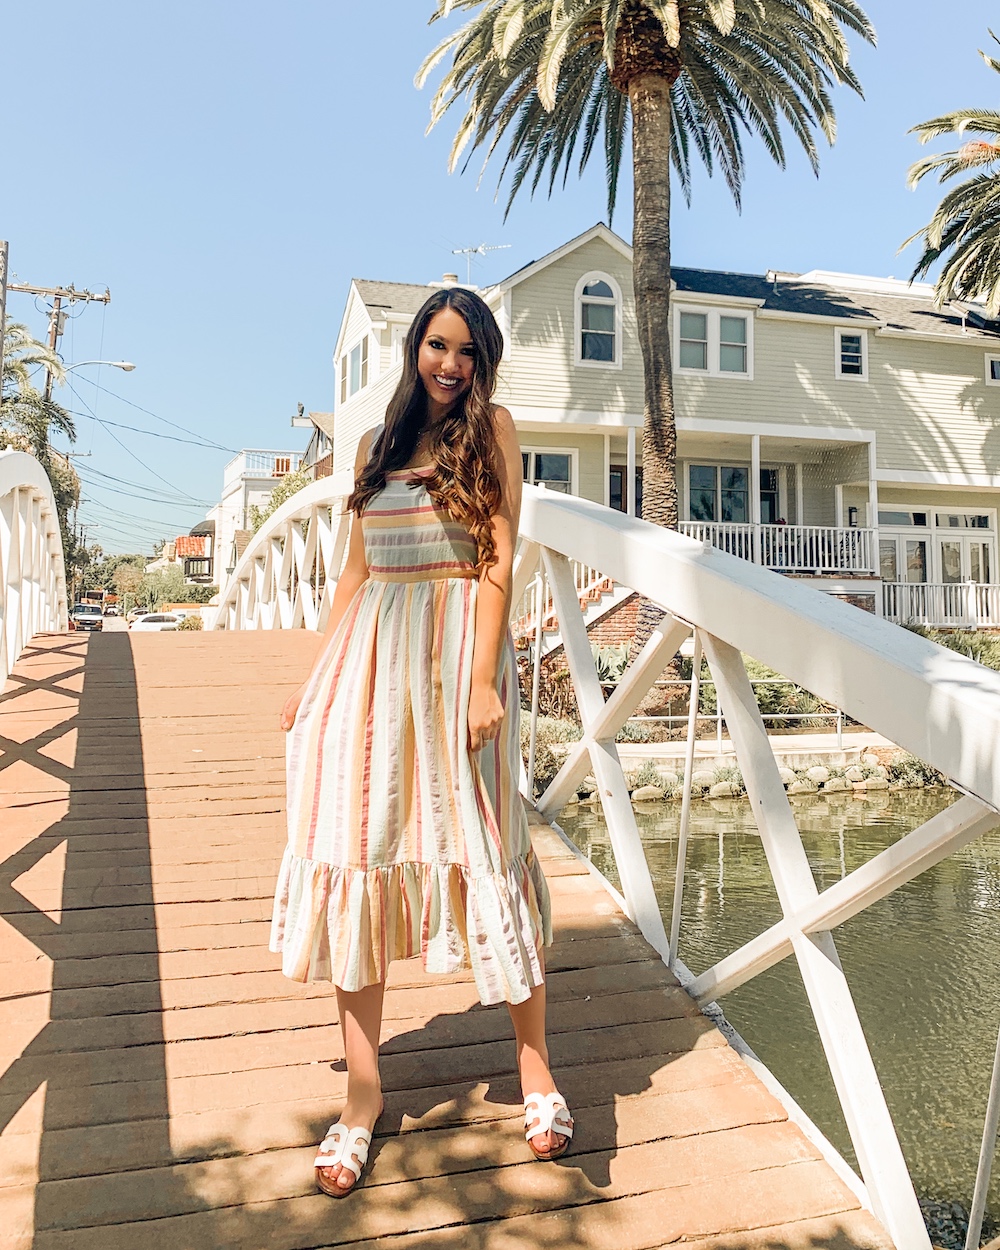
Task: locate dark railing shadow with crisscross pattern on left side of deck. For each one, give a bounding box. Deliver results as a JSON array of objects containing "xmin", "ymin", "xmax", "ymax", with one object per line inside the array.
[{"xmin": 0, "ymin": 634, "xmax": 203, "ymax": 1245}]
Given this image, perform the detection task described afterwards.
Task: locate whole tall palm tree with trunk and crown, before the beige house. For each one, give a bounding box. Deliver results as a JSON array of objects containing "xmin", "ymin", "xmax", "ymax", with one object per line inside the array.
[{"xmin": 416, "ymin": 0, "xmax": 875, "ymax": 542}]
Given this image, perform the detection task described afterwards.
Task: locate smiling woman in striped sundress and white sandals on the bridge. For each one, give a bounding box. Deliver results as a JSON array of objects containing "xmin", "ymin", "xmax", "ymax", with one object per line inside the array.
[{"xmin": 271, "ymin": 288, "xmax": 573, "ymax": 1198}]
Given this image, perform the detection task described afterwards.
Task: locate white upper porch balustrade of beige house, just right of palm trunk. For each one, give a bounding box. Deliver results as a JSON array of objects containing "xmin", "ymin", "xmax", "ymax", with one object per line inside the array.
[{"xmin": 678, "ymin": 521, "xmax": 878, "ymax": 576}]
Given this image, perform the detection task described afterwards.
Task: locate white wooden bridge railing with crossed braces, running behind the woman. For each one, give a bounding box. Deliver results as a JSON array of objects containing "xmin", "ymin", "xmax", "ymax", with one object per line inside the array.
[{"xmin": 216, "ymin": 479, "xmax": 1000, "ymax": 1250}]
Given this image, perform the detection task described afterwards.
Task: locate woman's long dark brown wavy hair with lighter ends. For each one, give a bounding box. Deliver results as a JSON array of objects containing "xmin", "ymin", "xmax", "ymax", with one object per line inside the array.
[{"xmin": 348, "ymin": 286, "xmax": 504, "ymax": 573}]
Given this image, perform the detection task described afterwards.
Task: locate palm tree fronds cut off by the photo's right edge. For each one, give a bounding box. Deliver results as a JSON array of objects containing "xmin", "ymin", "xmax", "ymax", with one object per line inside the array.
[{"xmin": 903, "ymin": 33, "xmax": 1000, "ymax": 316}]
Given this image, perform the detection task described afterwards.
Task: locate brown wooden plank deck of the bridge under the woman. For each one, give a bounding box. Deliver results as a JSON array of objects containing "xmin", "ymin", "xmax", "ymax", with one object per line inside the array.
[{"xmin": 0, "ymin": 633, "xmax": 890, "ymax": 1250}]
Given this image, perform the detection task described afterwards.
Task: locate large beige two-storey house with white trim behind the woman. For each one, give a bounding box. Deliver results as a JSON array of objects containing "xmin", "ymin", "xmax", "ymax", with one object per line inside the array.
[{"xmin": 333, "ymin": 225, "xmax": 1000, "ymax": 625}]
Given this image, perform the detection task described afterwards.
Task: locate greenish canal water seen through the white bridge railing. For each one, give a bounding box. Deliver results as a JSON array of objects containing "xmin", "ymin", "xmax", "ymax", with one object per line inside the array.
[{"xmin": 559, "ymin": 789, "xmax": 1000, "ymax": 1218}]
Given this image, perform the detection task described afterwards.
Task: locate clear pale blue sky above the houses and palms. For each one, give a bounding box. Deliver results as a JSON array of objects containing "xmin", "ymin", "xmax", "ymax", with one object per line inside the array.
[{"xmin": 0, "ymin": 0, "xmax": 1000, "ymax": 551}]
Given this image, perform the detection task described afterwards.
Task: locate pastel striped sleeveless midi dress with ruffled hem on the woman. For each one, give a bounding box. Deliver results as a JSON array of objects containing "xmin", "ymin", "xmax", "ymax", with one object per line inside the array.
[{"xmin": 271, "ymin": 469, "xmax": 551, "ymax": 1004}]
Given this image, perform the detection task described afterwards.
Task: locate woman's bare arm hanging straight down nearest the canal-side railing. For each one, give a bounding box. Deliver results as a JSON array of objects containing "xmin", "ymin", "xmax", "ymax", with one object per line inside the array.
[{"xmin": 469, "ymin": 408, "xmax": 521, "ymax": 751}]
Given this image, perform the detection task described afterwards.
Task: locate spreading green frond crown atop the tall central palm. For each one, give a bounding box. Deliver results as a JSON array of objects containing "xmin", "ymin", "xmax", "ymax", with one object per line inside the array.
[{"xmin": 418, "ymin": 0, "xmax": 875, "ymax": 220}]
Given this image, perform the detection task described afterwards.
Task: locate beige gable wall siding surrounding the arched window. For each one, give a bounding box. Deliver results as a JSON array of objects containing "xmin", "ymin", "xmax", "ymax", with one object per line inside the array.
[{"xmin": 496, "ymin": 239, "xmax": 643, "ymax": 414}]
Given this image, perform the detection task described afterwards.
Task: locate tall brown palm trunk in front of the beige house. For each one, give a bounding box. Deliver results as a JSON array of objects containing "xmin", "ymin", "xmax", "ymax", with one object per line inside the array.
[{"xmin": 629, "ymin": 74, "xmax": 678, "ymax": 658}]
